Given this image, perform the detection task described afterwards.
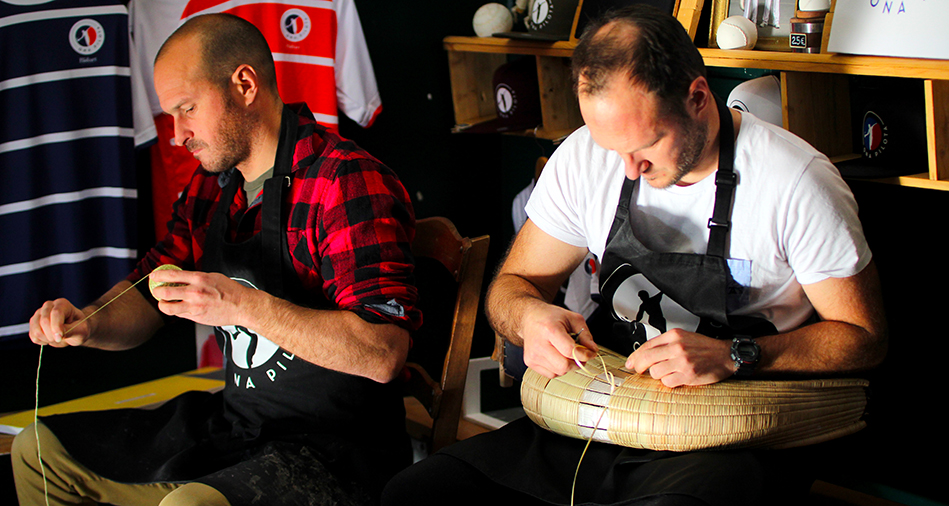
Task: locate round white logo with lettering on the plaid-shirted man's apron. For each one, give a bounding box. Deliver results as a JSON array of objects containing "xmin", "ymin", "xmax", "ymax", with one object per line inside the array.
[{"xmin": 218, "ymin": 278, "xmax": 296, "ymax": 388}]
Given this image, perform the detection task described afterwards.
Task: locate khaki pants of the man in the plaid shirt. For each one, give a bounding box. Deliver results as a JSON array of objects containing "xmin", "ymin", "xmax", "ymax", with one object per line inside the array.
[{"xmin": 11, "ymin": 422, "xmax": 230, "ymax": 506}]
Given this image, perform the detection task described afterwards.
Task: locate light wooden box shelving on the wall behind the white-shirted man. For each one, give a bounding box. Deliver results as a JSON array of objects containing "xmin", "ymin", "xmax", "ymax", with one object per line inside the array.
[{"xmin": 444, "ymin": 37, "xmax": 949, "ymax": 190}]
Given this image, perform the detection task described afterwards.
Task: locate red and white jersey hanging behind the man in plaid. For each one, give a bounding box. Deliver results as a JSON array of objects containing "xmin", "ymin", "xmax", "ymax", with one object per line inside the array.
[{"xmin": 129, "ymin": 0, "xmax": 382, "ymax": 240}]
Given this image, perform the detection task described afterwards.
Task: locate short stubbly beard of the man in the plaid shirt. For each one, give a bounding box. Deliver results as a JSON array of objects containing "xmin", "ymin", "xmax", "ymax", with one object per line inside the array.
[{"xmin": 186, "ymin": 97, "xmax": 260, "ymax": 174}]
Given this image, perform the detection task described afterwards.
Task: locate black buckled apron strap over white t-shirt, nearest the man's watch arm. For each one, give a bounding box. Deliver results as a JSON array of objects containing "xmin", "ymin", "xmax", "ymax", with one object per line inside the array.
[{"xmin": 706, "ymin": 95, "xmax": 738, "ymax": 258}]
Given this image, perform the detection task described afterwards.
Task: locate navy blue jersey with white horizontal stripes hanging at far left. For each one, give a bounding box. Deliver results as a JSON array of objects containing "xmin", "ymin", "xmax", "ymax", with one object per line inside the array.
[{"xmin": 0, "ymin": 0, "xmax": 138, "ymax": 345}]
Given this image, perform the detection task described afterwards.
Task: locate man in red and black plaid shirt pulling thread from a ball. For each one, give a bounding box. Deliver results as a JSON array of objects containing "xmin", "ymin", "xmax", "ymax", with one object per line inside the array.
[{"xmin": 14, "ymin": 14, "xmax": 421, "ymax": 505}]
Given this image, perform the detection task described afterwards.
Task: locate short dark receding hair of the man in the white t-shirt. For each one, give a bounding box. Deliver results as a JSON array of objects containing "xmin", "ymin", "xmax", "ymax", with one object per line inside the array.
[{"xmin": 571, "ymin": 4, "xmax": 706, "ymax": 116}]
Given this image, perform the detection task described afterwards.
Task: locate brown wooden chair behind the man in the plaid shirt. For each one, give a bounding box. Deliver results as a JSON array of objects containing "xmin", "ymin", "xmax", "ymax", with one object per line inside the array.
[{"xmin": 406, "ymin": 217, "xmax": 489, "ymax": 452}]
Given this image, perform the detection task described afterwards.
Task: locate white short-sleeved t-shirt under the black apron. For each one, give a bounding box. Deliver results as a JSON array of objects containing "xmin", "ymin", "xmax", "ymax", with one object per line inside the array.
[{"xmin": 527, "ymin": 113, "xmax": 871, "ymax": 332}]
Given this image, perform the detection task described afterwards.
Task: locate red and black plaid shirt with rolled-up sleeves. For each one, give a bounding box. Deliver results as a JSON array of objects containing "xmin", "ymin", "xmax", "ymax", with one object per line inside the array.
[{"xmin": 128, "ymin": 105, "xmax": 422, "ymax": 330}]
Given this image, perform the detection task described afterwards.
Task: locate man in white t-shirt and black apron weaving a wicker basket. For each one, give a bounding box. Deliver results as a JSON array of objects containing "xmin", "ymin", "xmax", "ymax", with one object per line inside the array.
[{"xmin": 384, "ymin": 4, "xmax": 887, "ymax": 506}]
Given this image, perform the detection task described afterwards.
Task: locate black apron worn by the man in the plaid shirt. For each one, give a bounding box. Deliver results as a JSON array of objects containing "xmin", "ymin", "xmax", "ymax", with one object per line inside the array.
[{"xmin": 44, "ymin": 107, "xmax": 411, "ymax": 505}]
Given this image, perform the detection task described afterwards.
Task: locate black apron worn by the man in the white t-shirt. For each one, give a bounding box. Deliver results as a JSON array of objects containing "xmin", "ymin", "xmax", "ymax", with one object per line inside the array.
[{"xmin": 443, "ymin": 96, "xmax": 800, "ymax": 505}]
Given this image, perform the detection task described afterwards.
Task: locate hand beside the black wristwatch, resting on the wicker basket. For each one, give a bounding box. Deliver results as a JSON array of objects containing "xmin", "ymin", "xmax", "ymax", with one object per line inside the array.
[{"xmin": 626, "ymin": 329, "xmax": 735, "ymax": 387}]
